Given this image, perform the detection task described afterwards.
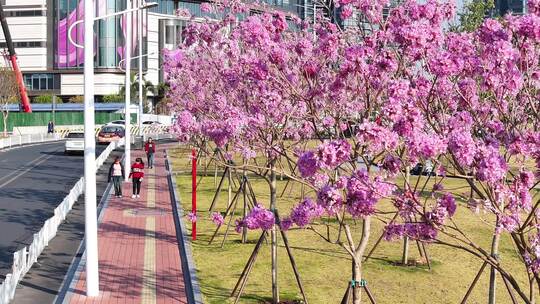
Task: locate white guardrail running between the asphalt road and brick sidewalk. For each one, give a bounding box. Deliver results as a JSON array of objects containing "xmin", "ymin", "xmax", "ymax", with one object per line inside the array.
[{"xmin": 0, "ymin": 139, "xmax": 124, "ymax": 304}]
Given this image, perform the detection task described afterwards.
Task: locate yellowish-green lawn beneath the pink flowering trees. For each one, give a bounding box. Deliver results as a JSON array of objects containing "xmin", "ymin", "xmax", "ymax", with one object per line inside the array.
[{"xmin": 170, "ymin": 150, "xmax": 526, "ymax": 304}]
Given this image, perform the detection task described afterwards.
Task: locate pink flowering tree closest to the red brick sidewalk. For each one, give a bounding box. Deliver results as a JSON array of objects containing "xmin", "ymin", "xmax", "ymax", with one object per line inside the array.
[{"xmin": 165, "ymin": 3, "xmax": 335, "ymax": 302}]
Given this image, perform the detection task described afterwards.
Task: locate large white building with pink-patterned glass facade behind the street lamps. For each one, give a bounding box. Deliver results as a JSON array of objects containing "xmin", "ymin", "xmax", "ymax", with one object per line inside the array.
[{"xmin": 0, "ymin": 0, "xmax": 304, "ymax": 101}]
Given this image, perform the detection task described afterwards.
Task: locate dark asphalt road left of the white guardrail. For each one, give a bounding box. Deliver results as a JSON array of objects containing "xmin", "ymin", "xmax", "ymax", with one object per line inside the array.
[{"xmin": 0, "ymin": 141, "xmax": 106, "ymax": 276}]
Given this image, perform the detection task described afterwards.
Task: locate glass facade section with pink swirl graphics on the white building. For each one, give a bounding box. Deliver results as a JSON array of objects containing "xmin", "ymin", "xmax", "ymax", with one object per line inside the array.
[{"xmin": 53, "ymin": 0, "xmax": 148, "ymax": 69}]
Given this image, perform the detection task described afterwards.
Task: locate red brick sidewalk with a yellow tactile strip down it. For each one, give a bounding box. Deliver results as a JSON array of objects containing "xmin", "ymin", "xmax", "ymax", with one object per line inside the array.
[{"xmin": 64, "ymin": 149, "xmax": 187, "ymax": 304}]
